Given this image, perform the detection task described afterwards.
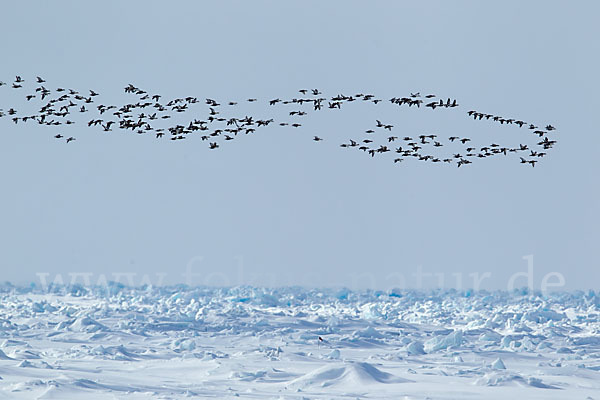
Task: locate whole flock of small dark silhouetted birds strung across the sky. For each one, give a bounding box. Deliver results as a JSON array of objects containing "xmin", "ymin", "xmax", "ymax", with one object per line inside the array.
[{"xmin": 0, "ymin": 75, "xmax": 557, "ymax": 167}]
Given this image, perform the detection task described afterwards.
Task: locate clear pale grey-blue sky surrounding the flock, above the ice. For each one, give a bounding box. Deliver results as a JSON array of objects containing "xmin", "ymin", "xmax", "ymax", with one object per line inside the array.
[{"xmin": 0, "ymin": 1, "xmax": 600, "ymax": 290}]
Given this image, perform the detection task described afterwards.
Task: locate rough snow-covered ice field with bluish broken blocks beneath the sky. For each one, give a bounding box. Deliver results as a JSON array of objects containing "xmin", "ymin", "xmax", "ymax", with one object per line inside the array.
[{"xmin": 0, "ymin": 286, "xmax": 600, "ymax": 400}]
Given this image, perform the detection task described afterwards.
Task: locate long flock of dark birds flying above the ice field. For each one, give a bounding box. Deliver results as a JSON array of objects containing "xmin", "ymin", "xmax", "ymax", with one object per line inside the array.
[{"xmin": 0, "ymin": 76, "xmax": 556, "ymax": 167}]
